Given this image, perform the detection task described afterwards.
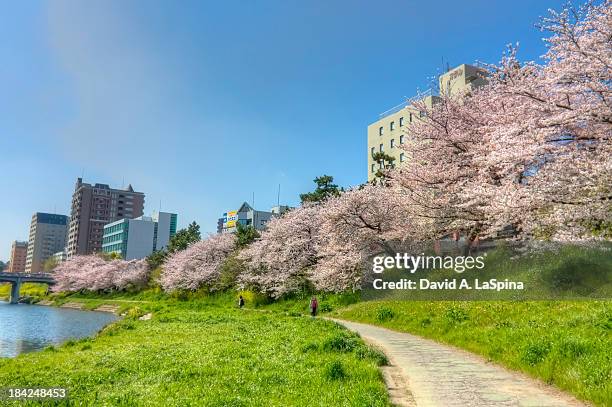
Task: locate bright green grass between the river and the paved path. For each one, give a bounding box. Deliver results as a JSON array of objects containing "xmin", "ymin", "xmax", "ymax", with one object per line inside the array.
[{"xmin": 0, "ymin": 296, "xmax": 389, "ymax": 407}]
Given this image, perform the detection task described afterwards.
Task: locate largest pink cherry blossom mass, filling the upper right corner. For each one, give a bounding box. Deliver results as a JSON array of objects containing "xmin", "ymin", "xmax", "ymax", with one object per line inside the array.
[{"xmin": 388, "ymin": 1, "xmax": 612, "ymax": 240}]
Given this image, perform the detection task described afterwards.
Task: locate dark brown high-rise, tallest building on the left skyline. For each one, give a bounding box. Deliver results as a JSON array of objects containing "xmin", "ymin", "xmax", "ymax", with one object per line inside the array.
[{"xmin": 66, "ymin": 178, "xmax": 144, "ymax": 258}]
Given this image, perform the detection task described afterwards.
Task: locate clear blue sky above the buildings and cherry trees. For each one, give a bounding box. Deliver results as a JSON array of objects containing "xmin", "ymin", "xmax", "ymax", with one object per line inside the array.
[{"xmin": 0, "ymin": 0, "xmax": 561, "ymax": 260}]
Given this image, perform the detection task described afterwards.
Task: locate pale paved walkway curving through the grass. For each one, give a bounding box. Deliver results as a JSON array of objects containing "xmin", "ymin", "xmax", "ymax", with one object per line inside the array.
[{"xmin": 334, "ymin": 319, "xmax": 584, "ymax": 407}]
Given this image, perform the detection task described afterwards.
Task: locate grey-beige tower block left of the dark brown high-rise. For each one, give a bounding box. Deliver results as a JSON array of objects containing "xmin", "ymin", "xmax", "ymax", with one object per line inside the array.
[{"xmin": 25, "ymin": 212, "xmax": 68, "ymax": 273}]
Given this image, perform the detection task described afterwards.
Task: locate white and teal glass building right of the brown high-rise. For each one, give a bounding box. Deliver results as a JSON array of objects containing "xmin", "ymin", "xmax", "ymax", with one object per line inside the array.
[{"xmin": 102, "ymin": 212, "xmax": 177, "ymax": 260}]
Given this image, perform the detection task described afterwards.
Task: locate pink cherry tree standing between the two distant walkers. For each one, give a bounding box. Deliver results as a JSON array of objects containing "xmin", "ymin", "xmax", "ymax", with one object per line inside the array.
[{"xmin": 238, "ymin": 204, "xmax": 322, "ymax": 298}]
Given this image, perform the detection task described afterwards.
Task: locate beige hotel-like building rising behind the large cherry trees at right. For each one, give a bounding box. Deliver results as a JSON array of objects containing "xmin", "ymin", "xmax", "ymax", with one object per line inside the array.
[{"xmin": 368, "ymin": 64, "xmax": 486, "ymax": 181}]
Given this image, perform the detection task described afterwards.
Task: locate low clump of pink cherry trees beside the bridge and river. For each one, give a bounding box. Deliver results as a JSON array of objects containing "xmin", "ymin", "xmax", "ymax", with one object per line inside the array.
[{"xmin": 53, "ymin": 255, "xmax": 148, "ymax": 291}]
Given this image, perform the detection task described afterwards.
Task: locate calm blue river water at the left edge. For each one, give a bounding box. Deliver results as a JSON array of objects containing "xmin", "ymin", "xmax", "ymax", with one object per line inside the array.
[{"xmin": 0, "ymin": 301, "xmax": 117, "ymax": 357}]
